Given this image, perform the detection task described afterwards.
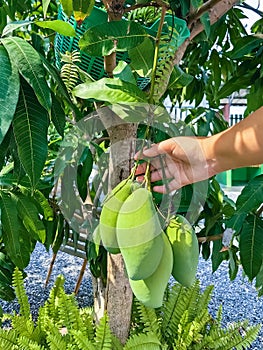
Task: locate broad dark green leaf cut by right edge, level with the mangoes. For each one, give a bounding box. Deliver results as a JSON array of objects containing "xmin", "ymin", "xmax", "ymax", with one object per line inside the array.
[{"xmin": 239, "ymin": 215, "xmax": 263, "ymax": 281}]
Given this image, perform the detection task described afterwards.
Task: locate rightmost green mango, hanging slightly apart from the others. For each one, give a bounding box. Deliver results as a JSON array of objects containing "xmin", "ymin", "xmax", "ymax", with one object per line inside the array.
[{"xmin": 166, "ymin": 215, "xmax": 199, "ymax": 287}]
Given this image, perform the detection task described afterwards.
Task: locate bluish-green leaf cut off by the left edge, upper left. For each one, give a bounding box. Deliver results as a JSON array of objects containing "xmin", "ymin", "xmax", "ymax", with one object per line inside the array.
[{"xmin": 0, "ymin": 45, "xmax": 20, "ymax": 144}]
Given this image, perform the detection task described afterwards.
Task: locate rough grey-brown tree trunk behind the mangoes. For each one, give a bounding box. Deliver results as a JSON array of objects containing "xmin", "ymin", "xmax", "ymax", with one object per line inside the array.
[{"xmin": 106, "ymin": 123, "xmax": 137, "ymax": 344}]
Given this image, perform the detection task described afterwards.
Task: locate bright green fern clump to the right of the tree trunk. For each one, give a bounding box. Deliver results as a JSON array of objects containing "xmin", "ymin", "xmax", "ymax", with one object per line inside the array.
[{"xmin": 128, "ymin": 281, "xmax": 261, "ymax": 350}]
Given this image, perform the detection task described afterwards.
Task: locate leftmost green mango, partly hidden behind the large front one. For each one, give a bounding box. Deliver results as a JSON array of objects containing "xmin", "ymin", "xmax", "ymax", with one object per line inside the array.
[{"xmin": 100, "ymin": 179, "xmax": 134, "ymax": 254}]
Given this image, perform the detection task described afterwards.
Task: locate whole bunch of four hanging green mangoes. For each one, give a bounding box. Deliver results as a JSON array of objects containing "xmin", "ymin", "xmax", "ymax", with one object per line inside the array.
[{"xmin": 98, "ymin": 179, "xmax": 199, "ymax": 308}]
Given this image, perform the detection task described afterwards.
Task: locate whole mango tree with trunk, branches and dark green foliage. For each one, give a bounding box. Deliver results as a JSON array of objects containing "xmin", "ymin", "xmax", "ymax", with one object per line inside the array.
[{"xmin": 0, "ymin": 0, "xmax": 263, "ymax": 343}]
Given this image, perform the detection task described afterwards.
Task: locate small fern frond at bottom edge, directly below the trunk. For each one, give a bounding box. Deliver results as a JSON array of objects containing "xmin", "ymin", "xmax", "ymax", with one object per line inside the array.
[{"xmin": 123, "ymin": 333, "xmax": 161, "ymax": 350}]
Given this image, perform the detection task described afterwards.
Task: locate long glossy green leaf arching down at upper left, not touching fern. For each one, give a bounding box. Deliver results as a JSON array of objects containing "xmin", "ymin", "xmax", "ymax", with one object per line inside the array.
[{"xmin": 1, "ymin": 37, "xmax": 51, "ymax": 111}]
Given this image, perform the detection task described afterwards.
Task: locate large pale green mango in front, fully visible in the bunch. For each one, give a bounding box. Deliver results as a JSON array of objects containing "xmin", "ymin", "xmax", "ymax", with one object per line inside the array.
[{"xmin": 116, "ymin": 188, "xmax": 164, "ymax": 280}]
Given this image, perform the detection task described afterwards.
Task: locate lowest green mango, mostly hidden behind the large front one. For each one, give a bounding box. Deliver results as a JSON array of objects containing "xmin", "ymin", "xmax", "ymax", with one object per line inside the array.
[{"xmin": 129, "ymin": 233, "xmax": 173, "ymax": 308}]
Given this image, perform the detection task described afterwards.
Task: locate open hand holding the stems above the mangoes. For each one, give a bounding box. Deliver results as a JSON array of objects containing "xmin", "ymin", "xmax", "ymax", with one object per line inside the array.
[{"xmin": 135, "ymin": 136, "xmax": 217, "ymax": 193}]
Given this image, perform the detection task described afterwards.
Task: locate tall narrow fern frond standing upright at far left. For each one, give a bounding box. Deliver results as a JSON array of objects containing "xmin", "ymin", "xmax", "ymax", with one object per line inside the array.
[{"xmin": 12, "ymin": 267, "xmax": 31, "ymax": 319}]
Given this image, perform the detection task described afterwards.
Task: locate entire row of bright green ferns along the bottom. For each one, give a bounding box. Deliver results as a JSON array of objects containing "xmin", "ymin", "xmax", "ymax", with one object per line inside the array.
[{"xmin": 0, "ymin": 268, "xmax": 260, "ymax": 350}]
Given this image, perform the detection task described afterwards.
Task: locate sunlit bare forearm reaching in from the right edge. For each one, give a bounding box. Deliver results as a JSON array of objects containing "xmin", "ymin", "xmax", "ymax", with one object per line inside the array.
[{"xmin": 202, "ymin": 107, "xmax": 263, "ymax": 173}]
